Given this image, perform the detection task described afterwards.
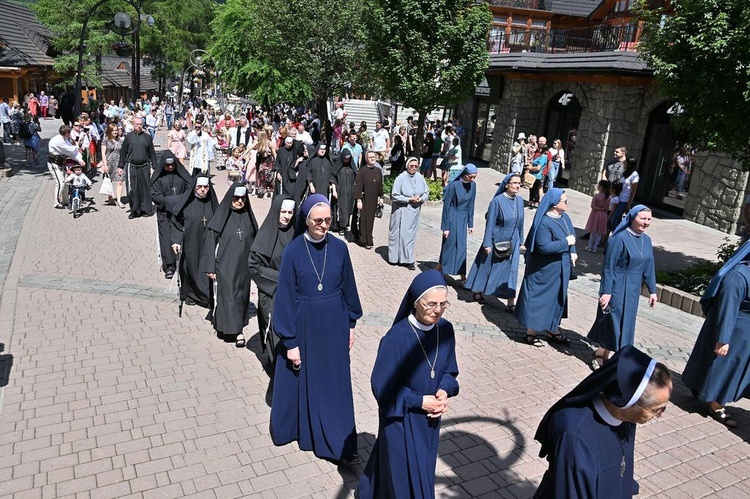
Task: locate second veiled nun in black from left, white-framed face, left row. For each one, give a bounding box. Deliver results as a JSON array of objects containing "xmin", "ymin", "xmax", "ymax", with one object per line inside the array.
[{"xmin": 167, "ymin": 174, "xmax": 219, "ymax": 312}]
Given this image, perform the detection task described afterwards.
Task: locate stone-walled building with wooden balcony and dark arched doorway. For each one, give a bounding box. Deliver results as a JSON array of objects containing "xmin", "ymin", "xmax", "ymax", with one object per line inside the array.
[{"xmin": 456, "ymin": 0, "xmax": 750, "ymax": 233}]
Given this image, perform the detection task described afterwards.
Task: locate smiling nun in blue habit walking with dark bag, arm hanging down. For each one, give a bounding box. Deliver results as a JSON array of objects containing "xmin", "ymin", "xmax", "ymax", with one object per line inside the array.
[{"xmin": 588, "ymin": 204, "xmax": 656, "ymax": 369}]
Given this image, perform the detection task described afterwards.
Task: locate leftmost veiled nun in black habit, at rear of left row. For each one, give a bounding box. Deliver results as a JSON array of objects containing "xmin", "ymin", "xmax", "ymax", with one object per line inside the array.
[{"xmin": 151, "ymin": 150, "xmax": 193, "ymax": 279}]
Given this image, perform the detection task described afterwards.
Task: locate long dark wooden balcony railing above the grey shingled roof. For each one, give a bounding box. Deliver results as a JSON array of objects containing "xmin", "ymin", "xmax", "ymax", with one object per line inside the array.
[{"xmin": 487, "ymin": 24, "xmax": 638, "ymax": 54}]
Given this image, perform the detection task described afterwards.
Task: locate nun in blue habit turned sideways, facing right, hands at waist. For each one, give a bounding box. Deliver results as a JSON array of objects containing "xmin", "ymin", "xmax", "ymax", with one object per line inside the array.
[{"xmin": 515, "ymin": 187, "xmax": 578, "ymax": 347}]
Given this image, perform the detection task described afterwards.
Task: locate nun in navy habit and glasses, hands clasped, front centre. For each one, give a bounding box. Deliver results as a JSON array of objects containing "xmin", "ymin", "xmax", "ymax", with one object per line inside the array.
[{"xmin": 359, "ymin": 270, "xmax": 458, "ymax": 499}]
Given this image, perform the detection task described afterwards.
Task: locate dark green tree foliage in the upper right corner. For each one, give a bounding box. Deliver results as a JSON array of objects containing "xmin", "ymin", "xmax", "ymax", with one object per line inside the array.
[{"xmin": 638, "ymin": 0, "xmax": 750, "ymax": 169}]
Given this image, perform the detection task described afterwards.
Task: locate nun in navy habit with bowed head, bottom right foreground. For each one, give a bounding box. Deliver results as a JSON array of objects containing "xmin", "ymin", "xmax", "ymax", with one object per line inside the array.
[{"xmin": 534, "ymin": 345, "xmax": 672, "ymax": 499}]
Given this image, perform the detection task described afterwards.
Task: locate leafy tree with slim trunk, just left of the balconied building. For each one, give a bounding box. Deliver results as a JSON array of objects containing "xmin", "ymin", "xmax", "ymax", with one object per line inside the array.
[{"xmin": 367, "ymin": 0, "xmax": 492, "ymax": 145}]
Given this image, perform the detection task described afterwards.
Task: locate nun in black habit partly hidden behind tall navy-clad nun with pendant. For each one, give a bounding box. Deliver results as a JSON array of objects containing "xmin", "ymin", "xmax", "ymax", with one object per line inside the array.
[{"xmin": 249, "ymin": 194, "xmax": 295, "ymax": 361}]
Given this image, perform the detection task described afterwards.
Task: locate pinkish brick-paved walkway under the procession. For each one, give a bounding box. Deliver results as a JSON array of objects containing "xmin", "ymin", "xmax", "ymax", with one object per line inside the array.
[{"xmin": 0, "ymin": 122, "xmax": 750, "ymax": 498}]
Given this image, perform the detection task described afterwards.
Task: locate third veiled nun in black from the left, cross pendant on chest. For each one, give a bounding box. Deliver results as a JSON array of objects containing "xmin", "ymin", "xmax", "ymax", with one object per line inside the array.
[{"xmin": 200, "ymin": 182, "xmax": 258, "ymax": 348}]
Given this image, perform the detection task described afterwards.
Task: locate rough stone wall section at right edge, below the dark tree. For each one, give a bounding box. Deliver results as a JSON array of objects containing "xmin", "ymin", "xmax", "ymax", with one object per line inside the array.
[{"xmin": 685, "ymin": 153, "xmax": 748, "ymax": 234}]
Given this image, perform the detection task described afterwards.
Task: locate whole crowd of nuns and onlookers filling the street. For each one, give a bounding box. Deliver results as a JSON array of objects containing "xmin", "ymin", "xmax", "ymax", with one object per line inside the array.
[{"xmin": 30, "ymin": 94, "xmax": 750, "ymax": 498}]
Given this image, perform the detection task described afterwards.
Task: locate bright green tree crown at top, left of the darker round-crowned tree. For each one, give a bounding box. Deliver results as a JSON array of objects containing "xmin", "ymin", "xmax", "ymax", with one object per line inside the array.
[{"xmin": 209, "ymin": 0, "xmax": 367, "ymax": 103}]
